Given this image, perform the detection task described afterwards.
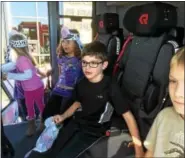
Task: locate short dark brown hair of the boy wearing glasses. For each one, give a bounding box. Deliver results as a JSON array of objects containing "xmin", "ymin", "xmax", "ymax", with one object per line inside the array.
[{"xmin": 82, "ymin": 41, "xmax": 108, "ymax": 62}]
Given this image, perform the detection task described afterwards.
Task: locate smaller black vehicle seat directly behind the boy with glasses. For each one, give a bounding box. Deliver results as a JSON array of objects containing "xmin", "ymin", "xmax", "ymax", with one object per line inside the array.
[{"xmin": 92, "ymin": 13, "xmax": 123, "ymax": 76}]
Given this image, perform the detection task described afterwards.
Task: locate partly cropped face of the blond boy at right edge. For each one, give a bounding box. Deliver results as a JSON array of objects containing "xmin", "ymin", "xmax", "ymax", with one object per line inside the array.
[{"xmin": 169, "ymin": 64, "xmax": 184, "ymax": 117}]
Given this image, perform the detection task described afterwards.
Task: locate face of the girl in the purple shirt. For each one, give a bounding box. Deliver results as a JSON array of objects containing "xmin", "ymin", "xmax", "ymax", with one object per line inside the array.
[{"xmin": 62, "ymin": 40, "xmax": 75, "ymax": 54}]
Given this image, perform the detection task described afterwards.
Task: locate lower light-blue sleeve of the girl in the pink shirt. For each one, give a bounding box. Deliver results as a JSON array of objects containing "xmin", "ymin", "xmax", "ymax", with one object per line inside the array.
[{"xmin": 7, "ymin": 69, "xmax": 33, "ymax": 81}]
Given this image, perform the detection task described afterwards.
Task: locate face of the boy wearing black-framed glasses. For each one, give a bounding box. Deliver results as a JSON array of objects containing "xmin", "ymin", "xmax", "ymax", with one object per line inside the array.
[{"xmin": 82, "ymin": 55, "xmax": 108, "ymax": 82}]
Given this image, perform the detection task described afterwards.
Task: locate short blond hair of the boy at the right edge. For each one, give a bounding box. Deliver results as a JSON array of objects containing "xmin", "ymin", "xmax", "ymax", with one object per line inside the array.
[{"xmin": 170, "ymin": 46, "xmax": 185, "ymax": 67}]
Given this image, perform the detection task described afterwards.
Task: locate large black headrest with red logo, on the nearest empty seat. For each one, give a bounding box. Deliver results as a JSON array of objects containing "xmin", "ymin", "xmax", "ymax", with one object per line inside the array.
[{"xmin": 123, "ymin": 2, "xmax": 177, "ymax": 36}]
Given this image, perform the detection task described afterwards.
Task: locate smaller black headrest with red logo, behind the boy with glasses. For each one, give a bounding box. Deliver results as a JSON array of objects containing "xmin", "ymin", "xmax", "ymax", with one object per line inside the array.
[{"xmin": 92, "ymin": 13, "xmax": 119, "ymax": 34}]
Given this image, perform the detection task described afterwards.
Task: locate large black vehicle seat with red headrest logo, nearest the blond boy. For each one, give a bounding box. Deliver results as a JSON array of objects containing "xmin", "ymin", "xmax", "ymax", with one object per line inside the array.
[{"xmin": 117, "ymin": 2, "xmax": 177, "ymax": 140}]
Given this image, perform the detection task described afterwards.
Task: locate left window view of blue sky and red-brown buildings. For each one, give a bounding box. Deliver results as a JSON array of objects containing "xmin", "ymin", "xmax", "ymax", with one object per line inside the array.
[{"xmin": 4, "ymin": 2, "xmax": 50, "ymax": 71}]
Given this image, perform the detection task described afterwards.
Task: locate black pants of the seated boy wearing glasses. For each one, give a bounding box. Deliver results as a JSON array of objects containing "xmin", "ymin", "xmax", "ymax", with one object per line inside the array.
[{"xmin": 28, "ymin": 120, "xmax": 100, "ymax": 158}]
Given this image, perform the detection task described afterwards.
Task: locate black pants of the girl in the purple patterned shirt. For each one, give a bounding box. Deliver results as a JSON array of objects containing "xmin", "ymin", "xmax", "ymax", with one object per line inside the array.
[{"xmin": 42, "ymin": 94, "xmax": 72, "ymax": 121}]
